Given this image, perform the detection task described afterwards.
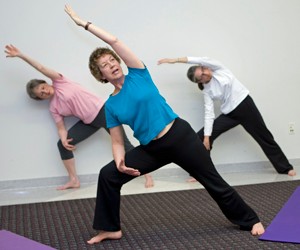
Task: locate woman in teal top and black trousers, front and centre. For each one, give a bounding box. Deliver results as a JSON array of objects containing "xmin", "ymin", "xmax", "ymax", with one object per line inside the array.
[{"xmin": 65, "ymin": 6, "xmax": 264, "ymax": 244}]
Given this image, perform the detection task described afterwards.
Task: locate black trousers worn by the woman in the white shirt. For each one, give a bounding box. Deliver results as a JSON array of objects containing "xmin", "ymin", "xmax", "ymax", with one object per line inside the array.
[{"xmin": 197, "ymin": 96, "xmax": 293, "ymax": 174}]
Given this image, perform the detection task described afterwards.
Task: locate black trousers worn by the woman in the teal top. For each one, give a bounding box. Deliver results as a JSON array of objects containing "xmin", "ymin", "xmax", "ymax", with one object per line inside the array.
[{"xmin": 93, "ymin": 118, "xmax": 259, "ymax": 231}]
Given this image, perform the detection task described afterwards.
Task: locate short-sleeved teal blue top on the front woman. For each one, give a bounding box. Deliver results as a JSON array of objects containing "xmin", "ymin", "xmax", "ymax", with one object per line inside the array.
[{"xmin": 105, "ymin": 67, "xmax": 178, "ymax": 145}]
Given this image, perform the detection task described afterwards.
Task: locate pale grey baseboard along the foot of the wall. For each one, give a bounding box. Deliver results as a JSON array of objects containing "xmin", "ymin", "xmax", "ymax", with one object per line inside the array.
[{"xmin": 0, "ymin": 159, "xmax": 300, "ymax": 191}]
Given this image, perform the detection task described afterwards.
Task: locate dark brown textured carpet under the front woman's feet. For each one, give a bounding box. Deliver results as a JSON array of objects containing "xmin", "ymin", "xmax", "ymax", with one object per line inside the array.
[{"xmin": 0, "ymin": 180, "xmax": 300, "ymax": 250}]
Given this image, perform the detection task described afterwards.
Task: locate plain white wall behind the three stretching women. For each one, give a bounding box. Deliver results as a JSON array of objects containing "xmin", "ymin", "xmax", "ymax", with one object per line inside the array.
[{"xmin": 0, "ymin": 0, "xmax": 300, "ymax": 181}]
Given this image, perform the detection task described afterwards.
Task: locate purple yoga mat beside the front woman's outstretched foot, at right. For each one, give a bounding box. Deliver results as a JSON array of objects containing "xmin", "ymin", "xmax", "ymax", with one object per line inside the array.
[{"xmin": 259, "ymin": 187, "xmax": 300, "ymax": 243}]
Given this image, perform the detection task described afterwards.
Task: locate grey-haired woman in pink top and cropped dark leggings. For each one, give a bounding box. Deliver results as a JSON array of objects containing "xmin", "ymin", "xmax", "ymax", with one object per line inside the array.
[{"xmin": 5, "ymin": 45, "xmax": 153, "ymax": 190}]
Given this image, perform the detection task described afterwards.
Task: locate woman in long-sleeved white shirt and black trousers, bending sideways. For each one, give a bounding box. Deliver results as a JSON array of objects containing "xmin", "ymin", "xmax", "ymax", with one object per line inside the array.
[{"xmin": 158, "ymin": 57, "xmax": 296, "ymax": 176}]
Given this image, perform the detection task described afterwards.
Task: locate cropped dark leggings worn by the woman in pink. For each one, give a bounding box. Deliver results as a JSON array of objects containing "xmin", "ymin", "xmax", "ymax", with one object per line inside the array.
[{"xmin": 57, "ymin": 106, "xmax": 134, "ymax": 160}]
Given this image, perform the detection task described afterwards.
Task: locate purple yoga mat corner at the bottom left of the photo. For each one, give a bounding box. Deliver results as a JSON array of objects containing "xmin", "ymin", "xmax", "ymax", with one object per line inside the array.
[{"xmin": 0, "ymin": 230, "xmax": 55, "ymax": 250}]
